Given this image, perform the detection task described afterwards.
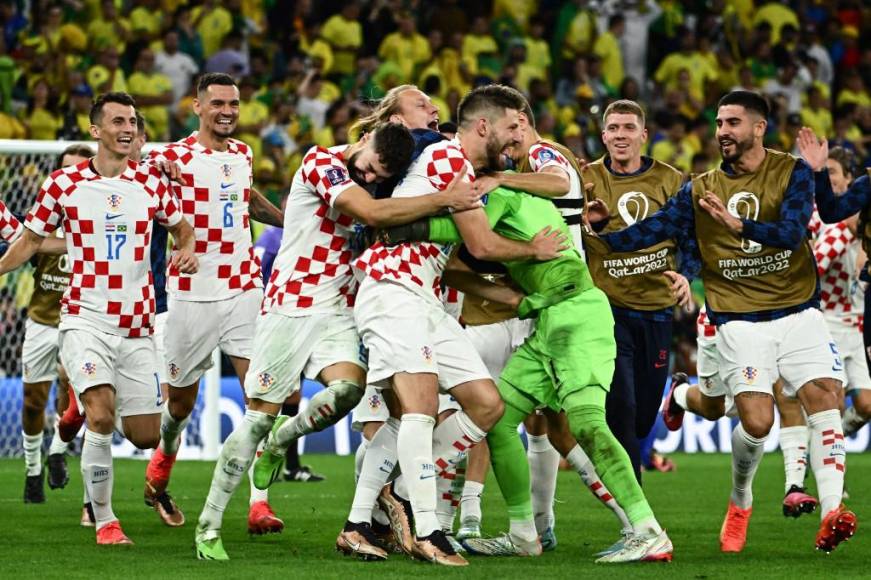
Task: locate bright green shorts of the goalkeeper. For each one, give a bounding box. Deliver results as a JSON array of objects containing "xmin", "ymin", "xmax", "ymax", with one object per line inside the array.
[{"xmin": 499, "ymin": 288, "xmax": 617, "ymax": 411}]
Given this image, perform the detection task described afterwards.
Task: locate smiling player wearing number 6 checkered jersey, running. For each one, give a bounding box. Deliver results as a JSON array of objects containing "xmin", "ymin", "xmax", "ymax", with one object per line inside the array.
[{"xmin": 145, "ymin": 73, "xmax": 284, "ymax": 534}]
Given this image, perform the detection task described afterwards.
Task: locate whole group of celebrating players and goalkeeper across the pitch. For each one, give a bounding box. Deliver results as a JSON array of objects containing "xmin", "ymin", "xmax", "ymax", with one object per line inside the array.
[{"xmin": 0, "ymin": 74, "xmax": 871, "ymax": 566}]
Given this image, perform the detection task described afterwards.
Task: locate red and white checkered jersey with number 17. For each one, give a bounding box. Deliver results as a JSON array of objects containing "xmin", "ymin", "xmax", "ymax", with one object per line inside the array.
[{"xmin": 24, "ymin": 161, "xmax": 182, "ymax": 337}]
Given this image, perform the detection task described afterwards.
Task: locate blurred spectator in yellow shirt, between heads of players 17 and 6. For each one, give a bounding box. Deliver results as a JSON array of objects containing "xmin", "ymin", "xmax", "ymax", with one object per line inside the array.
[{"xmin": 127, "ymin": 48, "xmax": 173, "ymax": 141}]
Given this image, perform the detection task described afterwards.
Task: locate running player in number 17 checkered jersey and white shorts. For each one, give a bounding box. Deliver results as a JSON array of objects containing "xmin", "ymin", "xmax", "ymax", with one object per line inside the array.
[{"xmin": 0, "ymin": 93, "xmax": 197, "ymax": 544}]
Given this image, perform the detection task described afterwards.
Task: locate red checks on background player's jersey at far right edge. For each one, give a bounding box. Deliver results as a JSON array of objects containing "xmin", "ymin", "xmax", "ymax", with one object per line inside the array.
[{"xmin": 814, "ymin": 222, "xmax": 856, "ymax": 314}]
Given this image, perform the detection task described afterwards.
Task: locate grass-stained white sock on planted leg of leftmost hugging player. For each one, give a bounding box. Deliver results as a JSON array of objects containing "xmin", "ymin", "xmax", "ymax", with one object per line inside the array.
[{"xmin": 197, "ymin": 409, "xmax": 275, "ymax": 531}]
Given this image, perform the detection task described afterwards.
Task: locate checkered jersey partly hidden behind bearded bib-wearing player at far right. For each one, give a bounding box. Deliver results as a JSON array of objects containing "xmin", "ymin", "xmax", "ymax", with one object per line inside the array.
[{"xmin": 814, "ymin": 222, "xmax": 864, "ymax": 326}]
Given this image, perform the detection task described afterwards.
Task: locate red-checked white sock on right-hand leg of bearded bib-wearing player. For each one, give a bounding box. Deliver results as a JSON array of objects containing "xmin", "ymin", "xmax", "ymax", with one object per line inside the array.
[{"xmin": 807, "ymin": 409, "xmax": 847, "ymax": 518}]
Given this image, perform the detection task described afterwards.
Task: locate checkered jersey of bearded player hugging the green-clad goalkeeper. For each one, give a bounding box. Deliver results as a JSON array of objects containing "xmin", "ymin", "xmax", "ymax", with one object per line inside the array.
[{"xmin": 354, "ymin": 140, "xmax": 475, "ymax": 301}]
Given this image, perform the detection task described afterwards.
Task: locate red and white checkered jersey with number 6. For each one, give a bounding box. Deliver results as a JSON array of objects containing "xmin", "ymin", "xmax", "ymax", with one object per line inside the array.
[{"xmin": 151, "ymin": 133, "xmax": 263, "ymax": 302}]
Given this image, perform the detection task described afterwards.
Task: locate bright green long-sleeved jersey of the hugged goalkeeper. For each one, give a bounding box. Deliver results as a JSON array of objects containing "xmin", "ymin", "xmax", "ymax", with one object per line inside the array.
[{"xmin": 429, "ymin": 187, "xmax": 594, "ymax": 318}]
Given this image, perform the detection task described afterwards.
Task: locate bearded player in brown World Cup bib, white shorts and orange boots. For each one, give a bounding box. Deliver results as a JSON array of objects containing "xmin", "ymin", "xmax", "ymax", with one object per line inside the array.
[{"xmin": 603, "ymin": 90, "xmax": 856, "ymax": 552}]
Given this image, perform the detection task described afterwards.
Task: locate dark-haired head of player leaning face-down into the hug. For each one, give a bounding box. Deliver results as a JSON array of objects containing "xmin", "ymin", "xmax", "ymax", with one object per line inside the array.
[{"xmin": 348, "ymin": 123, "xmax": 414, "ymax": 185}]
